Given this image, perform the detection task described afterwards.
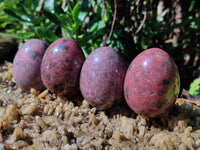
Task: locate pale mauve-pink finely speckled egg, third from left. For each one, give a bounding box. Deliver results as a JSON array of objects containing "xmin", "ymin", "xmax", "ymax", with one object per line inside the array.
[{"xmin": 80, "ymin": 47, "xmax": 127, "ymax": 109}]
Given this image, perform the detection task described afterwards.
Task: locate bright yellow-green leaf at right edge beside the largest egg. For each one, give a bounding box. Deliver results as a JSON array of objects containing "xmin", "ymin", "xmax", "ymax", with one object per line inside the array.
[{"xmin": 189, "ymin": 78, "xmax": 200, "ymax": 95}]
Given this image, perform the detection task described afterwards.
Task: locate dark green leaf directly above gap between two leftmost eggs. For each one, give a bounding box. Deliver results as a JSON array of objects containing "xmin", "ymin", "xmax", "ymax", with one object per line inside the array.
[{"xmin": 35, "ymin": 27, "xmax": 59, "ymax": 44}]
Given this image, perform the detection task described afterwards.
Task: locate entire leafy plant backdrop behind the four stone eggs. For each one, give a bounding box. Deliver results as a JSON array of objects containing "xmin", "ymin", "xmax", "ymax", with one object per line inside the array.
[{"xmin": 0, "ymin": 0, "xmax": 200, "ymax": 95}]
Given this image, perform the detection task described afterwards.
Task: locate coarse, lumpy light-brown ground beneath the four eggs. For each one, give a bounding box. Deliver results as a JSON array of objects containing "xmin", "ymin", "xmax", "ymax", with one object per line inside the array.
[{"xmin": 0, "ymin": 62, "xmax": 200, "ymax": 150}]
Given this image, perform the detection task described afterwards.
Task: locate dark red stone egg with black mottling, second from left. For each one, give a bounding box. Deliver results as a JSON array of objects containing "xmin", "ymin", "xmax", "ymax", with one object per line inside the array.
[{"xmin": 41, "ymin": 38, "xmax": 85, "ymax": 96}]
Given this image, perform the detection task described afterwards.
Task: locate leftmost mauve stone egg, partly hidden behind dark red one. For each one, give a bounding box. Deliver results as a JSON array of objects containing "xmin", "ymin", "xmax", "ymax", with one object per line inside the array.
[{"xmin": 13, "ymin": 39, "xmax": 47, "ymax": 91}]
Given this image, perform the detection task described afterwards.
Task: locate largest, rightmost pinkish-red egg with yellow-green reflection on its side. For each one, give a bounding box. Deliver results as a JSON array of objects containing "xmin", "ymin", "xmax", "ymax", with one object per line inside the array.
[{"xmin": 124, "ymin": 48, "xmax": 180, "ymax": 118}]
